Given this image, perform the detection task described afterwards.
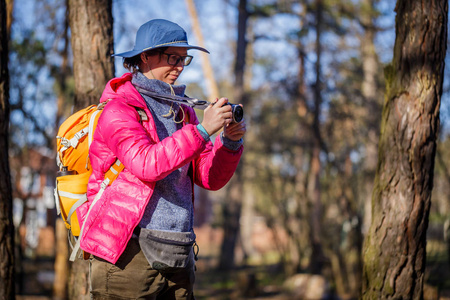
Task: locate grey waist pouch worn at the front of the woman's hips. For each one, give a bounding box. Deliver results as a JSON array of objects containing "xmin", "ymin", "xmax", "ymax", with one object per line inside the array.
[{"xmin": 139, "ymin": 228, "xmax": 195, "ymax": 271}]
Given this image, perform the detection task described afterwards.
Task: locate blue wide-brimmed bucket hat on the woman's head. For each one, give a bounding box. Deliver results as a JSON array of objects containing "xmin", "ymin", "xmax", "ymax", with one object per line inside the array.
[{"xmin": 113, "ymin": 19, "xmax": 209, "ymax": 57}]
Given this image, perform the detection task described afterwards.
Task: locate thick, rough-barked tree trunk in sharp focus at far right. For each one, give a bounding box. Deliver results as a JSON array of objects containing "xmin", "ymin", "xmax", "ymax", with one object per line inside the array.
[{"xmin": 363, "ymin": 0, "xmax": 448, "ymax": 299}]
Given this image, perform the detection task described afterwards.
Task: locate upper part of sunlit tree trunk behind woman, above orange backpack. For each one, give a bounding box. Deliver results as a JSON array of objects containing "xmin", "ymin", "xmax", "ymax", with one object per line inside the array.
[{"xmin": 69, "ymin": 0, "xmax": 114, "ymax": 111}]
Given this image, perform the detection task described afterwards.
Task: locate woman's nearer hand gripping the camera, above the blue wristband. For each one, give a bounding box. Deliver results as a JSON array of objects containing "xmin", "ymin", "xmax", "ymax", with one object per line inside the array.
[{"xmin": 202, "ymin": 98, "xmax": 233, "ymax": 136}]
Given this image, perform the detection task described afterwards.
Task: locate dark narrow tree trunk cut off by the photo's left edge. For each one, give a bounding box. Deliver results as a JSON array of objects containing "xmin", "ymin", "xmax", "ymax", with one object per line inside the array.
[{"xmin": 0, "ymin": 0, "xmax": 15, "ymax": 299}]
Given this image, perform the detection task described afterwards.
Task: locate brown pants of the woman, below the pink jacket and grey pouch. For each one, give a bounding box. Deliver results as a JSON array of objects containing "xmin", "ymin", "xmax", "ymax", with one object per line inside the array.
[{"xmin": 90, "ymin": 238, "xmax": 195, "ymax": 300}]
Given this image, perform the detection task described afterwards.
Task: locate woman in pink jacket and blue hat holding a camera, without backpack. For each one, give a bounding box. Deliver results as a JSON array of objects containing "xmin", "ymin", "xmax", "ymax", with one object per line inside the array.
[{"xmin": 77, "ymin": 19, "xmax": 246, "ymax": 299}]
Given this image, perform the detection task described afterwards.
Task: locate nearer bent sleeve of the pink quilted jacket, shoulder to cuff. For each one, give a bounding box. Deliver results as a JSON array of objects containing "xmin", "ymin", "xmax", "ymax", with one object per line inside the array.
[{"xmin": 96, "ymin": 101, "xmax": 207, "ymax": 181}]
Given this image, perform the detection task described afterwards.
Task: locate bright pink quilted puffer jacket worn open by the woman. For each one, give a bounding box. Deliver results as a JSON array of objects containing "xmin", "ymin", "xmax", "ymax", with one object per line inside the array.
[{"xmin": 77, "ymin": 73, "xmax": 243, "ymax": 263}]
